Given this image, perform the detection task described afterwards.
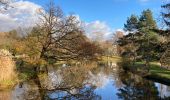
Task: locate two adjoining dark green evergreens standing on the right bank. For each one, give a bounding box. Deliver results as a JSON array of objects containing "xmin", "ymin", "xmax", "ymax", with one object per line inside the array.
[{"xmin": 118, "ymin": 9, "xmax": 158, "ymax": 68}]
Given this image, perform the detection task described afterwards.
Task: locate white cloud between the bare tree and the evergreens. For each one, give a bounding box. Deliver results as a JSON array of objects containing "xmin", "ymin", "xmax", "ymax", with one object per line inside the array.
[{"xmin": 84, "ymin": 21, "xmax": 113, "ymax": 41}]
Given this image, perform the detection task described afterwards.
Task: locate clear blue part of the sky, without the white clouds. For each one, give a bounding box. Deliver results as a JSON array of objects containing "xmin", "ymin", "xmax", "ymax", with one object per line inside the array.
[{"xmin": 29, "ymin": 0, "xmax": 163, "ymax": 29}]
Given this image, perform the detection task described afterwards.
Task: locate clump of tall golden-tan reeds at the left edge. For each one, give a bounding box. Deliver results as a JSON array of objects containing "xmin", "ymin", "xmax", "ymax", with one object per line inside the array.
[{"xmin": 0, "ymin": 50, "xmax": 17, "ymax": 87}]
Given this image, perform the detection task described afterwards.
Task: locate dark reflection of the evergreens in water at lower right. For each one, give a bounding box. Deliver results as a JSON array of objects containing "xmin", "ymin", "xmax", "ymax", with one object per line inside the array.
[{"xmin": 117, "ymin": 73, "xmax": 159, "ymax": 100}]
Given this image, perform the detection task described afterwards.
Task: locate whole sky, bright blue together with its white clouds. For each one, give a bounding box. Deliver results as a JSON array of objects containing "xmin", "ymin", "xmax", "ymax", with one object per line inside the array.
[{"xmin": 0, "ymin": 0, "xmax": 167, "ymax": 39}]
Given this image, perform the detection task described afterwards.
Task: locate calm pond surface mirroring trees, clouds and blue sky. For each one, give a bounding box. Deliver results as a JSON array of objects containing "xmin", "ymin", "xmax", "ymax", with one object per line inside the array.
[{"xmin": 0, "ymin": 62, "xmax": 170, "ymax": 100}]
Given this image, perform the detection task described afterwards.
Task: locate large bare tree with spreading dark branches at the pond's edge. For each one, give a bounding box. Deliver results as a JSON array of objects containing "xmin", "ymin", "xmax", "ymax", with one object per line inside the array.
[{"xmin": 26, "ymin": 1, "xmax": 85, "ymax": 61}]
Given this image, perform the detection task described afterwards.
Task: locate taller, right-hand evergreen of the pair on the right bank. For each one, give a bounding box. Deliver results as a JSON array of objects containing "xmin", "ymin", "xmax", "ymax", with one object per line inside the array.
[{"xmin": 138, "ymin": 9, "xmax": 158, "ymax": 66}]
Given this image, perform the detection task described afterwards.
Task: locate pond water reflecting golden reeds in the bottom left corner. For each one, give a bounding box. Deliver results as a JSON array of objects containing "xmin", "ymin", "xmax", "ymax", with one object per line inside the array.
[{"xmin": 0, "ymin": 81, "xmax": 41, "ymax": 100}]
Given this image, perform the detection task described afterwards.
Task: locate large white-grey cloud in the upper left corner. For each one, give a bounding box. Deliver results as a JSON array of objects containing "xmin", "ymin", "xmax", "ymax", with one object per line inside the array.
[{"xmin": 0, "ymin": 1, "xmax": 41, "ymax": 31}]
